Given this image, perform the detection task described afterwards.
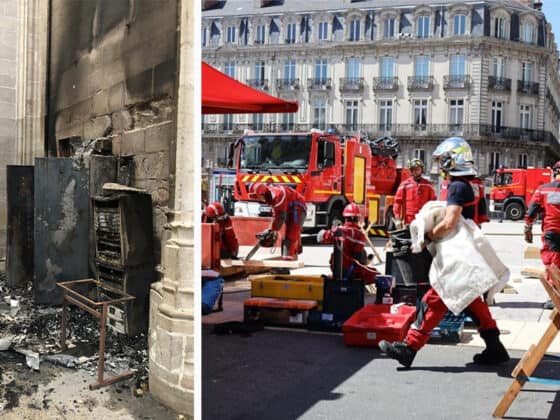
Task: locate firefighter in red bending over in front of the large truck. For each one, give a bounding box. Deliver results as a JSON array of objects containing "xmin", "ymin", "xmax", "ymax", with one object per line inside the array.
[{"xmin": 249, "ymin": 182, "xmax": 307, "ymax": 260}]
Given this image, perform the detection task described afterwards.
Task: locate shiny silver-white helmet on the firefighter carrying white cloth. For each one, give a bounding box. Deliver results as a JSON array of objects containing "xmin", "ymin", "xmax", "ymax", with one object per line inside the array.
[{"xmin": 432, "ymin": 137, "xmax": 476, "ymax": 176}]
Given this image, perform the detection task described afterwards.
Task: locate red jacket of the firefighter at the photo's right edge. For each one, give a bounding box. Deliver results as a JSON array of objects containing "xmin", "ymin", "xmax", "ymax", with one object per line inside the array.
[{"xmin": 525, "ymin": 181, "xmax": 560, "ymax": 233}]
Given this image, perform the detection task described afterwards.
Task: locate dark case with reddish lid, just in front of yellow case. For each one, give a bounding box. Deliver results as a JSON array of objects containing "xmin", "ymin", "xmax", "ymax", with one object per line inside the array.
[{"xmin": 243, "ymin": 298, "xmax": 317, "ymax": 327}]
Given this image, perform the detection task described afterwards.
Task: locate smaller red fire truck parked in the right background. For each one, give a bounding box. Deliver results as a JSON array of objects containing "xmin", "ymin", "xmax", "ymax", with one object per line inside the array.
[{"xmin": 490, "ymin": 168, "xmax": 552, "ymax": 220}]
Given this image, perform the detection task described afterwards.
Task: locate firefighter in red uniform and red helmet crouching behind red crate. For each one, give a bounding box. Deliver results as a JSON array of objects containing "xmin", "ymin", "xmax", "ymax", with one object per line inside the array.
[{"xmin": 317, "ymin": 203, "xmax": 377, "ymax": 284}]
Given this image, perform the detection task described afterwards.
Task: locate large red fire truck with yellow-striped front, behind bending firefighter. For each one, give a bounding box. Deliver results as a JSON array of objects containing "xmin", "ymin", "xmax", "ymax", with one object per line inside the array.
[{"xmin": 230, "ymin": 130, "xmax": 410, "ymax": 236}]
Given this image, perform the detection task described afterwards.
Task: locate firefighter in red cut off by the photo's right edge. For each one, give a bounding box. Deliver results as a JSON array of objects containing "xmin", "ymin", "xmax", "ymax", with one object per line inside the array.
[{"xmin": 525, "ymin": 160, "xmax": 560, "ymax": 309}]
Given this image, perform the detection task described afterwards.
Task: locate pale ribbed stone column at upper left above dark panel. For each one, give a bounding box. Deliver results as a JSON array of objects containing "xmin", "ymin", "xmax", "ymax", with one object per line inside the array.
[{"xmin": 15, "ymin": 0, "xmax": 49, "ymax": 165}]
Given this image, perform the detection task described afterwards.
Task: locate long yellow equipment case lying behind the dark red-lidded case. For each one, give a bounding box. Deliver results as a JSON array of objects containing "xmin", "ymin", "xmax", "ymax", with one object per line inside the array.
[{"xmin": 250, "ymin": 274, "xmax": 324, "ymax": 302}]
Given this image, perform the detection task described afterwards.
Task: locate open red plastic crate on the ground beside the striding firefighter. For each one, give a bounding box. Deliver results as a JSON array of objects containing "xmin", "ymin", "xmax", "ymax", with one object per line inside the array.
[{"xmin": 342, "ymin": 304, "xmax": 416, "ymax": 347}]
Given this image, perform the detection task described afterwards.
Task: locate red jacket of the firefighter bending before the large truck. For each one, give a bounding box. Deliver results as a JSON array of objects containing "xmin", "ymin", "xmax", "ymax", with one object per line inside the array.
[{"xmin": 268, "ymin": 185, "xmax": 307, "ymax": 231}]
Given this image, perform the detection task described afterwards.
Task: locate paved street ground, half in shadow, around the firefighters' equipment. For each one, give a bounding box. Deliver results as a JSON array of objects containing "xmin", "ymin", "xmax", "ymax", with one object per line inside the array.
[{"xmin": 202, "ymin": 221, "xmax": 560, "ymax": 419}]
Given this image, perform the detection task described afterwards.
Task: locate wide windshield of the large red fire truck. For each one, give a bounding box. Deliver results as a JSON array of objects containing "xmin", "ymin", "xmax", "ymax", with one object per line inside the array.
[{"xmin": 240, "ymin": 134, "xmax": 311, "ymax": 170}]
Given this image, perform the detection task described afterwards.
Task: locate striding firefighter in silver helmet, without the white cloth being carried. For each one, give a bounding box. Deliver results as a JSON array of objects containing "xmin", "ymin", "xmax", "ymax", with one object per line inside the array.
[{"xmin": 379, "ymin": 137, "xmax": 509, "ymax": 367}]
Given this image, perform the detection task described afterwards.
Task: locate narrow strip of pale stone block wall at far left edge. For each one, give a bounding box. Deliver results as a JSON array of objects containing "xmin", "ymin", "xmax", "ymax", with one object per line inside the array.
[{"xmin": 0, "ymin": 0, "xmax": 18, "ymax": 258}]
